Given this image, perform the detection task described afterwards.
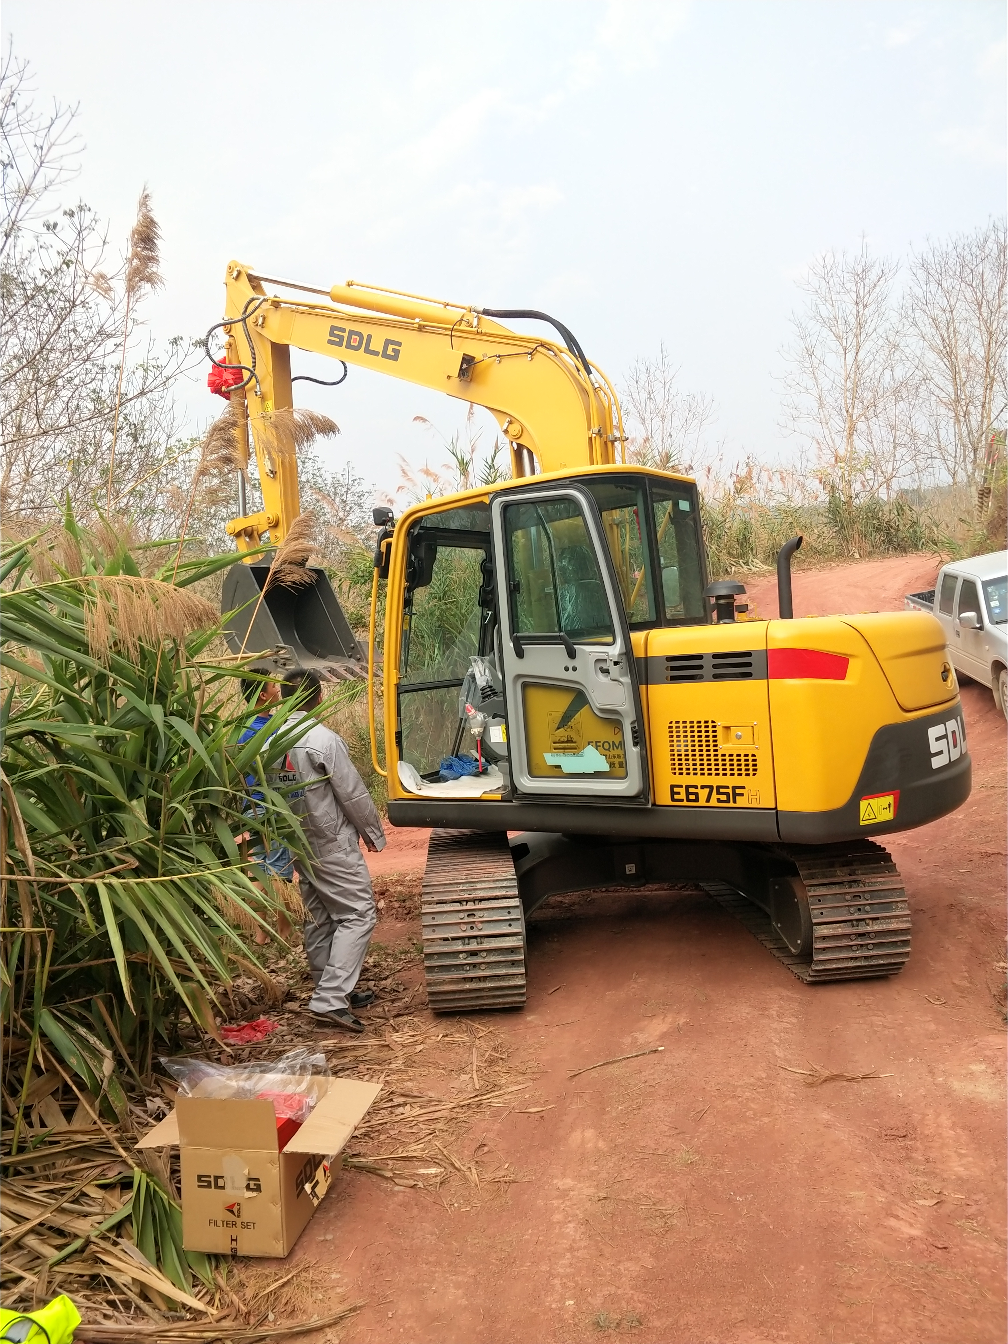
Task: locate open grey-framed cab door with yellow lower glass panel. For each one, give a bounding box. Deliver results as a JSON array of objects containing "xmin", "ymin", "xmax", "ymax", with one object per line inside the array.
[{"xmin": 492, "ymin": 485, "xmax": 648, "ymax": 802}]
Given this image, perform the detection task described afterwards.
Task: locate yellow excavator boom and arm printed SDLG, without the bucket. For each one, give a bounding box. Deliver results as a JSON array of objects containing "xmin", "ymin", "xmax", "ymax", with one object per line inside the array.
[{"xmin": 215, "ymin": 261, "xmax": 624, "ymax": 551}]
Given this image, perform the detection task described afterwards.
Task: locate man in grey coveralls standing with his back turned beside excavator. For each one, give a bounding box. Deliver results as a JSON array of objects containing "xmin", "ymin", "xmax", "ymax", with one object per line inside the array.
[{"xmin": 284, "ymin": 672, "xmax": 384, "ymax": 1031}]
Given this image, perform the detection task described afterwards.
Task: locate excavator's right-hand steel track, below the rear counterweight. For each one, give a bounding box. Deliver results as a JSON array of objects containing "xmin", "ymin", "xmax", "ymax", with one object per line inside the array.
[{"xmin": 703, "ymin": 840, "xmax": 910, "ymax": 984}]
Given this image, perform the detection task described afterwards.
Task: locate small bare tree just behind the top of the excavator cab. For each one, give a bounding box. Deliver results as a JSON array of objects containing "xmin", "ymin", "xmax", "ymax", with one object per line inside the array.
[{"xmin": 622, "ymin": 344, "xmax": 714, "ymax": 472}]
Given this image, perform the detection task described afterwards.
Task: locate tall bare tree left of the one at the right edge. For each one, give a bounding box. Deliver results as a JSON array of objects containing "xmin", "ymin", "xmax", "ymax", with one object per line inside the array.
[{"xmin": 781, "ymin": 243, "xmax": 922, "ymax": 509}]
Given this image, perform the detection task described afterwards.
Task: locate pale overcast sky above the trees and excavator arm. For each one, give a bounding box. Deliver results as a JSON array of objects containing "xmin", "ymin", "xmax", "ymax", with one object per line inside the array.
[{"xmin": 3, "ymin": 0, "xmax": 1005, "ymax": 489}]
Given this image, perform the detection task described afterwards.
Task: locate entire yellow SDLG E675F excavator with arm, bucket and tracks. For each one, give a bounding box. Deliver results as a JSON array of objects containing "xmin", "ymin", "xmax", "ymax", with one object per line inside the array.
[{"xmin": 207, "ymin": 262, "xmax": 972, "ymax": 1012}]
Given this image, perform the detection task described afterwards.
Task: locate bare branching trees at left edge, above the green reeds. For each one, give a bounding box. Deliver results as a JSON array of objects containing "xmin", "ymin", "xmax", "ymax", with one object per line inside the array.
[{"xmin": 0, "ymin": 51, "xmax": 191, "ymax": 535}]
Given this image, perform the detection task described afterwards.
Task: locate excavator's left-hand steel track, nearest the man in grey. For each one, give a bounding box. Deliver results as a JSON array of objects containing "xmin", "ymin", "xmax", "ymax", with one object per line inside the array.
[{"xmin": 421, "ymin": 831, "xmax": 526, "ymax": 1012}]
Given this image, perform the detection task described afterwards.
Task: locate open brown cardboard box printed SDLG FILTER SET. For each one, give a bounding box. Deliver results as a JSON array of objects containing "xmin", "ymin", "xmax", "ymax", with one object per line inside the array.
[{"xmin": 137, "ymin": 1078, "xmax": 380, "ymax": 1255}]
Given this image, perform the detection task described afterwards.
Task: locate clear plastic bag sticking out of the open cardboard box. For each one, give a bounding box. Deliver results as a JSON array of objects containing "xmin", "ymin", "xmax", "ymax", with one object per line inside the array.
[{"xmin": 161, "ymin": 1048, "xmax": 331, "ymax": 1125}]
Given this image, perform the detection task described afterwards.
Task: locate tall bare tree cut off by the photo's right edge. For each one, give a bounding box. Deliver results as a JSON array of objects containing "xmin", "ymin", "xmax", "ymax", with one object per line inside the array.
[{"xmin": 909, "ymin": 219, "xmax": 1008, "ymax": 491}]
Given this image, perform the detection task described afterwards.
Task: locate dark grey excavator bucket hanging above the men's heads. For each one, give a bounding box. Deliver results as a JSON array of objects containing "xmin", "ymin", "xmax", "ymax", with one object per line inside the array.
[{"xmin": 220, "ymin": 564, "xmax": 367, "ymax": 680}]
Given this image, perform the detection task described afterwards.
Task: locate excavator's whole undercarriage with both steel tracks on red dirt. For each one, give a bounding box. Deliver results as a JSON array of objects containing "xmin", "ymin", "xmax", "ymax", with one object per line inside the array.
[{"xmin": 421, "ymin": 831, "xmax": 910, "ymax": 1012}]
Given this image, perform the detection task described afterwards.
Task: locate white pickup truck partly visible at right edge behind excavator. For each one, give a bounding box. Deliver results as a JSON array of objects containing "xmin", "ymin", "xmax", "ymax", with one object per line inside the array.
[{"xmin": 906, "ymin": 551, "xmax": 1008, "ymax": 718}]
